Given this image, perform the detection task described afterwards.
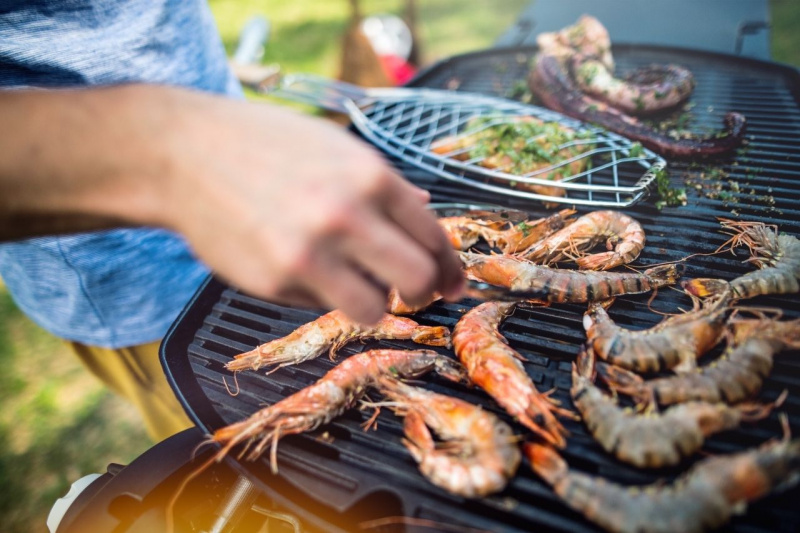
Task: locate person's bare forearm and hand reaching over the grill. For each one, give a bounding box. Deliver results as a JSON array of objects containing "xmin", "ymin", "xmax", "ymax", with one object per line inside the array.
[{"xmin": 0, "ymin": 85, "xmax": 462, "ymax": 322}]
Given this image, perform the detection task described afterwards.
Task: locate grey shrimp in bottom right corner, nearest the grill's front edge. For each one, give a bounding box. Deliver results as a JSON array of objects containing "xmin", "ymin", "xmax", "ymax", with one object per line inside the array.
[{"xmin": 524, "ymin": 430, "xmax": 800, "ymax": 533}]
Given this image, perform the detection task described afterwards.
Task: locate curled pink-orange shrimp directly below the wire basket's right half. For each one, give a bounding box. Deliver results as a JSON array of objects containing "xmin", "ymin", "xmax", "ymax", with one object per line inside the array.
[{"xmin": 518, "ymin": 211, "xmax": 645, "ymax": 270}]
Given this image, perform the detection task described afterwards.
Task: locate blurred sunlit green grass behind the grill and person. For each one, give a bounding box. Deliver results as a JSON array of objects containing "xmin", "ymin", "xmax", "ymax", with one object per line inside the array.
[{"xmin": 0, "ymin": 0, "xmax": 800, "ymax": 533}]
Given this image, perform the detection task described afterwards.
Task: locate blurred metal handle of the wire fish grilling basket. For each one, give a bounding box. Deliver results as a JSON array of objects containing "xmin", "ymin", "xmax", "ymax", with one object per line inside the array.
[{"xmin": 260, "ymin": 74, "xmax": 367, "ymax": 113}]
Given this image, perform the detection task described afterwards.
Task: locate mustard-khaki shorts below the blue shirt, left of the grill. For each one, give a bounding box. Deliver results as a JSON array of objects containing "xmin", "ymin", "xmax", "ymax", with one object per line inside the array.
[{"xmin": 67, "ymin": 342, "xmax": 193, "ymax": 442}]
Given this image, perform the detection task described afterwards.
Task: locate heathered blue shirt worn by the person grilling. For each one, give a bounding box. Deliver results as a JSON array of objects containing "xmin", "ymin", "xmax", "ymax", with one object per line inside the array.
[{"xmin": 0, "ymin": 0, "xmax": 241, "ymax": 348}]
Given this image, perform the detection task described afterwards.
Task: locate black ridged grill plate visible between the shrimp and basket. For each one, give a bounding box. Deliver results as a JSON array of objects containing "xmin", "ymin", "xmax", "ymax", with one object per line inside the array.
[{"xmin": 162, "ymin": 46, "xmax": 800, "ymax": 532}]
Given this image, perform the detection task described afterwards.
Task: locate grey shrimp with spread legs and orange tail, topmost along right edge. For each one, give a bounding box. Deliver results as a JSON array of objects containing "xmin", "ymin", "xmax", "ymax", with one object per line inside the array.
[{"xmin": 684, "ymin": 219, "xmax": 800, "ymax": 299}]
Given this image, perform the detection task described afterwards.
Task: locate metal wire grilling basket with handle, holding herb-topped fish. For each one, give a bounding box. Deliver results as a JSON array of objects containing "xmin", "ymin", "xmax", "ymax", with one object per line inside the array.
[{"xmin": 259, "ymin": 74, "xmax": 666, "ymax": 207}]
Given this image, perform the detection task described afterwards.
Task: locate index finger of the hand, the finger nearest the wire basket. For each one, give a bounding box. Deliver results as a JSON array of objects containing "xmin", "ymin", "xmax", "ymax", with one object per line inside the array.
[{"xmin": 382, "ymin": 174, "xmax": 464, "ymax": 300}]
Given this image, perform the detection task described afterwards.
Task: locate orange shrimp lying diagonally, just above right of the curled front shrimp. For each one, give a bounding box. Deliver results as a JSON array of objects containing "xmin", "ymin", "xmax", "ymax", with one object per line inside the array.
[{"xmin": 453, "ymin": 302, "xmax": 572, "ymax": 448}]
